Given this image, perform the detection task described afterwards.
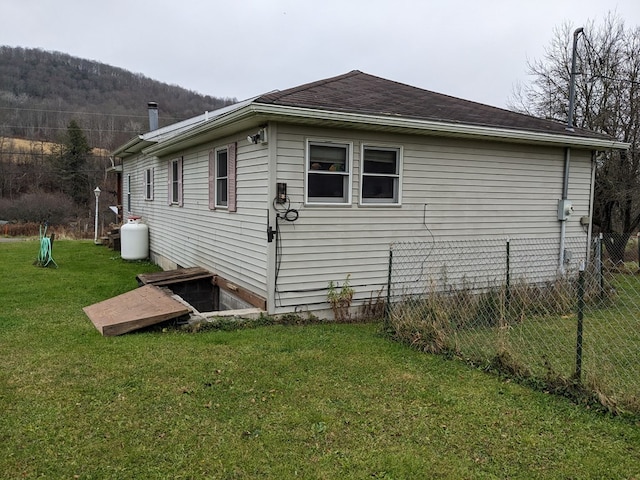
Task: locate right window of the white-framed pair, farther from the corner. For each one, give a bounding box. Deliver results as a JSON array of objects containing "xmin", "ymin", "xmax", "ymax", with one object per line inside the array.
[{"xmin": 360, "ymin": 145, "xmax": 402, "ymax": 205}]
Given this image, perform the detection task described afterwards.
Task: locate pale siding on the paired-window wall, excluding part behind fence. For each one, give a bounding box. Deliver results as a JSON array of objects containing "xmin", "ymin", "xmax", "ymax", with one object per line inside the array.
[{"xmin": 268, "ymin": 125, "xmax": 591, "ymax": 312}]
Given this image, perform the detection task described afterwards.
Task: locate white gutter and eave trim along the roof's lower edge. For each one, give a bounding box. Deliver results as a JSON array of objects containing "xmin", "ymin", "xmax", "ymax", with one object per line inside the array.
[{"xmin": 145, "ymin": 103, "xmax": 630, "ymax": 155}]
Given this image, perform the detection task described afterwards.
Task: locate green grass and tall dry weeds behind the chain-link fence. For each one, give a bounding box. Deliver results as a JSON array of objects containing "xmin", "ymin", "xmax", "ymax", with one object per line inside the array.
[{"xmin": 390, "ymin": 271, "xmax": 640, "ymax": 416}]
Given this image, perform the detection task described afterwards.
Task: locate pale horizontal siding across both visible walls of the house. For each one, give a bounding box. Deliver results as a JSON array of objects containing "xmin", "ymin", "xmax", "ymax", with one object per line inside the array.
[{"xmin": 123, "ymin": 124, "xmax": 591, "ymax": 313}]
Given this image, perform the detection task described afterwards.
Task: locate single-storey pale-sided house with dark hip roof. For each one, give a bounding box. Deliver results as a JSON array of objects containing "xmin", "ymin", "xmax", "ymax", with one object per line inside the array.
[{"xmin": 113, "ymin": 71, "xmax": 626, "ymax": 315}]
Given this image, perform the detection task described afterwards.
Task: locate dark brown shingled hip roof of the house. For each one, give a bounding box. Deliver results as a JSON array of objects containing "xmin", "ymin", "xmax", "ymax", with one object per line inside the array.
[{"xmin": 254, "ymin": 70, "xmax": 611, "ymax": 139}]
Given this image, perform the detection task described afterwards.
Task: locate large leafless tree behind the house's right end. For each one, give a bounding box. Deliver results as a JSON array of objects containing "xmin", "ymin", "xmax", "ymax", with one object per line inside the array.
[{"xmin": 510, "ymin": 13, "xmax": 640, "ymax": 263}]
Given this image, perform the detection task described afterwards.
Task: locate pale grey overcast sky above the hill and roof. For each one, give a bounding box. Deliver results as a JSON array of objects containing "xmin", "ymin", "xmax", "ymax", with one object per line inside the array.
[{"xmin": 0, "ymin": 0, "xmax": 640, "ymax": 108}]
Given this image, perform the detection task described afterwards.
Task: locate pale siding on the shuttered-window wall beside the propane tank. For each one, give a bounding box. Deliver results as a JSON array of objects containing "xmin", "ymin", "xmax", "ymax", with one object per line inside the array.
[{"xmin": 123, "ymin": 133, "xmax": 269, "ymax": 298}]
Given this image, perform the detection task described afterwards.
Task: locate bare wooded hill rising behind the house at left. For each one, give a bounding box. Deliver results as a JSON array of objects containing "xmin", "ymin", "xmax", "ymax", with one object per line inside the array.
[{"xmin": 0, "ymin": 46, "xmax": 235, "ymax": 150}]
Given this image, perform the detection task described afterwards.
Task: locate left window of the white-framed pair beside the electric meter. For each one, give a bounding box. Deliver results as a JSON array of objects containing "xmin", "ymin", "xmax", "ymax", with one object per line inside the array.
[{"xmin": 306, "ymin": 141, "xmax": 351, "ymax": 204}]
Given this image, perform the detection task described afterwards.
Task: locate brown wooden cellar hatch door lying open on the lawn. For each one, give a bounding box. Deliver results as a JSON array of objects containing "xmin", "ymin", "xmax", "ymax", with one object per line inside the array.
[{"xmin": 83, "ymin": 285, "xmax": 190, "ymax": 337}]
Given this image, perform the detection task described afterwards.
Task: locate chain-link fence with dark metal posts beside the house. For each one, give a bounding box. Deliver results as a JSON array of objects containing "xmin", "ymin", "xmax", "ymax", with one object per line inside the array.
[{"xmin": 386, "ymin": 237, "xmax": 640, "ymax": 412}]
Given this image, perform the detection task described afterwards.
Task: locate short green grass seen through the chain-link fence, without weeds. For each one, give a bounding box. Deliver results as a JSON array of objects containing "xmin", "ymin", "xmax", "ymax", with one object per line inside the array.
[{"xmin": 444, "ymin": 274, "xmax": 640, "ymax": 413}]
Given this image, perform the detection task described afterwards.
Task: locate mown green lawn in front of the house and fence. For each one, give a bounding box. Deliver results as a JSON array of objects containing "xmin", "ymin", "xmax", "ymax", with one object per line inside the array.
[{"xmin": 0, "ymin": 241, "xmax": 640, "ymax": 479}]
